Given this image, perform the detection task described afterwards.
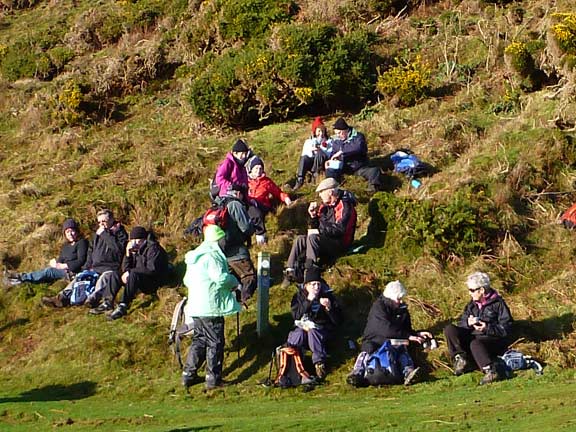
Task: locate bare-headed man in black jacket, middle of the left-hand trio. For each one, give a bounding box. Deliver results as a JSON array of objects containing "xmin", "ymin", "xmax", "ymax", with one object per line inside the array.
[{"xmin": 42, "ymin": 209, "xmax": 128, "ymax": 314}]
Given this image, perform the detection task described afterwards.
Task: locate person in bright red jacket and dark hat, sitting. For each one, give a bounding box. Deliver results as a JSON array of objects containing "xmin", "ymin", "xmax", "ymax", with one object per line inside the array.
[{"xmin": 246, "ymin": 156, "xmax": 292, "ymax": 244}]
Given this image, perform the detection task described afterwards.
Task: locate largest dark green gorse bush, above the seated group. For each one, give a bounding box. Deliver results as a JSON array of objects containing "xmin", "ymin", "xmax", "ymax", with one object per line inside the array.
[{"xmin": 189, "ymin": 24, "xmax": 374, "ymax": 126}]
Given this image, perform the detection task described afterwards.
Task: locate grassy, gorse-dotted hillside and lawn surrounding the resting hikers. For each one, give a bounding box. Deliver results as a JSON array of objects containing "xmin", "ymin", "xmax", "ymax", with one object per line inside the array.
[{"xmin": 0, "ymin": 0, "xmax": 576, "ymax": 430}]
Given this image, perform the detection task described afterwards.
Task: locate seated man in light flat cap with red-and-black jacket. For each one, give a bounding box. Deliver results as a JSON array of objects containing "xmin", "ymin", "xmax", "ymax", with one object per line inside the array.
[{"xmin": 282, "ymin": 177, "xmax": 357, "ymax": 287}]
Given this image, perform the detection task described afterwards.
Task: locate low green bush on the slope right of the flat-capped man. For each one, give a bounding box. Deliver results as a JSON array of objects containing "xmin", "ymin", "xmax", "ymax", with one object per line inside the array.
[{"xmin": 379, "ymin": 190, "xmax": 497, "ymax": 260}]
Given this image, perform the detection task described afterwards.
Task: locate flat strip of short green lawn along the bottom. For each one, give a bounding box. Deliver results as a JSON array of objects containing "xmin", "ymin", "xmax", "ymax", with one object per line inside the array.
[{"xmin": 0, "ymin": 370, "xmax": 576, "ymax": 431}]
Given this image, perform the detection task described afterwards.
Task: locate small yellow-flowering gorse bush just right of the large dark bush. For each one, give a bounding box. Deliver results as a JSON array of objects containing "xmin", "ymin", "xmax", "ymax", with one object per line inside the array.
[{"xmin": 376, "ymin": 56, "xmax": 431, "ymax": 106}]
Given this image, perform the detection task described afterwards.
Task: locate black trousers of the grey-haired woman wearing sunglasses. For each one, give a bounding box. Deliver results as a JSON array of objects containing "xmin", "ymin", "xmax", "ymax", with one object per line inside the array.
[{"xmin": 444, "ymin": 324, "xmax": 508, "ymax": 369}]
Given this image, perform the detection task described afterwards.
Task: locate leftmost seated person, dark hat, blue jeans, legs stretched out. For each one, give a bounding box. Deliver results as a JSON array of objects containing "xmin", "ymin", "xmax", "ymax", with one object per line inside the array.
[{"xmin": 8, "ymin": 219, "xmax": 88, "ymax": 285}]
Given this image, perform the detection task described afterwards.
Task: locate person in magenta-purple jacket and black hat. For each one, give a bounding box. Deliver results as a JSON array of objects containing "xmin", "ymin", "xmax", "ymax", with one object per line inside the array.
[{"xmin": 211, "ymin": 139, "xmax": 250, "ymax": 197}]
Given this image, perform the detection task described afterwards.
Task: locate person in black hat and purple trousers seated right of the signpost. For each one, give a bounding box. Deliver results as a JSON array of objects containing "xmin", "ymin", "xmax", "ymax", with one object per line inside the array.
[{"xmin": 287, "ymin": 268, "xmax": 341, "ymax": 379}]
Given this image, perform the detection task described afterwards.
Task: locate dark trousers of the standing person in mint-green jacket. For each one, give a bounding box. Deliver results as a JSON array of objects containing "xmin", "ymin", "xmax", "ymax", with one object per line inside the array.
[{"xmin": 184, "ymin": 317, "xmax": 225, "ymax": 386}]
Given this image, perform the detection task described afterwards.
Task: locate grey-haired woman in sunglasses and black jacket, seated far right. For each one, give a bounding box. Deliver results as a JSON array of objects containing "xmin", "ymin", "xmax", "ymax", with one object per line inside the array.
[{"xmin": 444, "ymin": 272, "xmax": 512, "ymax": 385}]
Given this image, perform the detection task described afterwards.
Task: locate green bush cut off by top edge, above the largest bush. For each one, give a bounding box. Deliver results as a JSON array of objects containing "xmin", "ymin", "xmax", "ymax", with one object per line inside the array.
[{"xmin": 219, "ymin": 0, "xmax": 298, "ymax": 42}]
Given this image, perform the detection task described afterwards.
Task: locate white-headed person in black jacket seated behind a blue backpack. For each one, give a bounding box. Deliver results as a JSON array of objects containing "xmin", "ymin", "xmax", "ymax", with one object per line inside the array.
[{"xmin": 346, "ymin": 280, "xmax": 433, "ymax": 387}]
